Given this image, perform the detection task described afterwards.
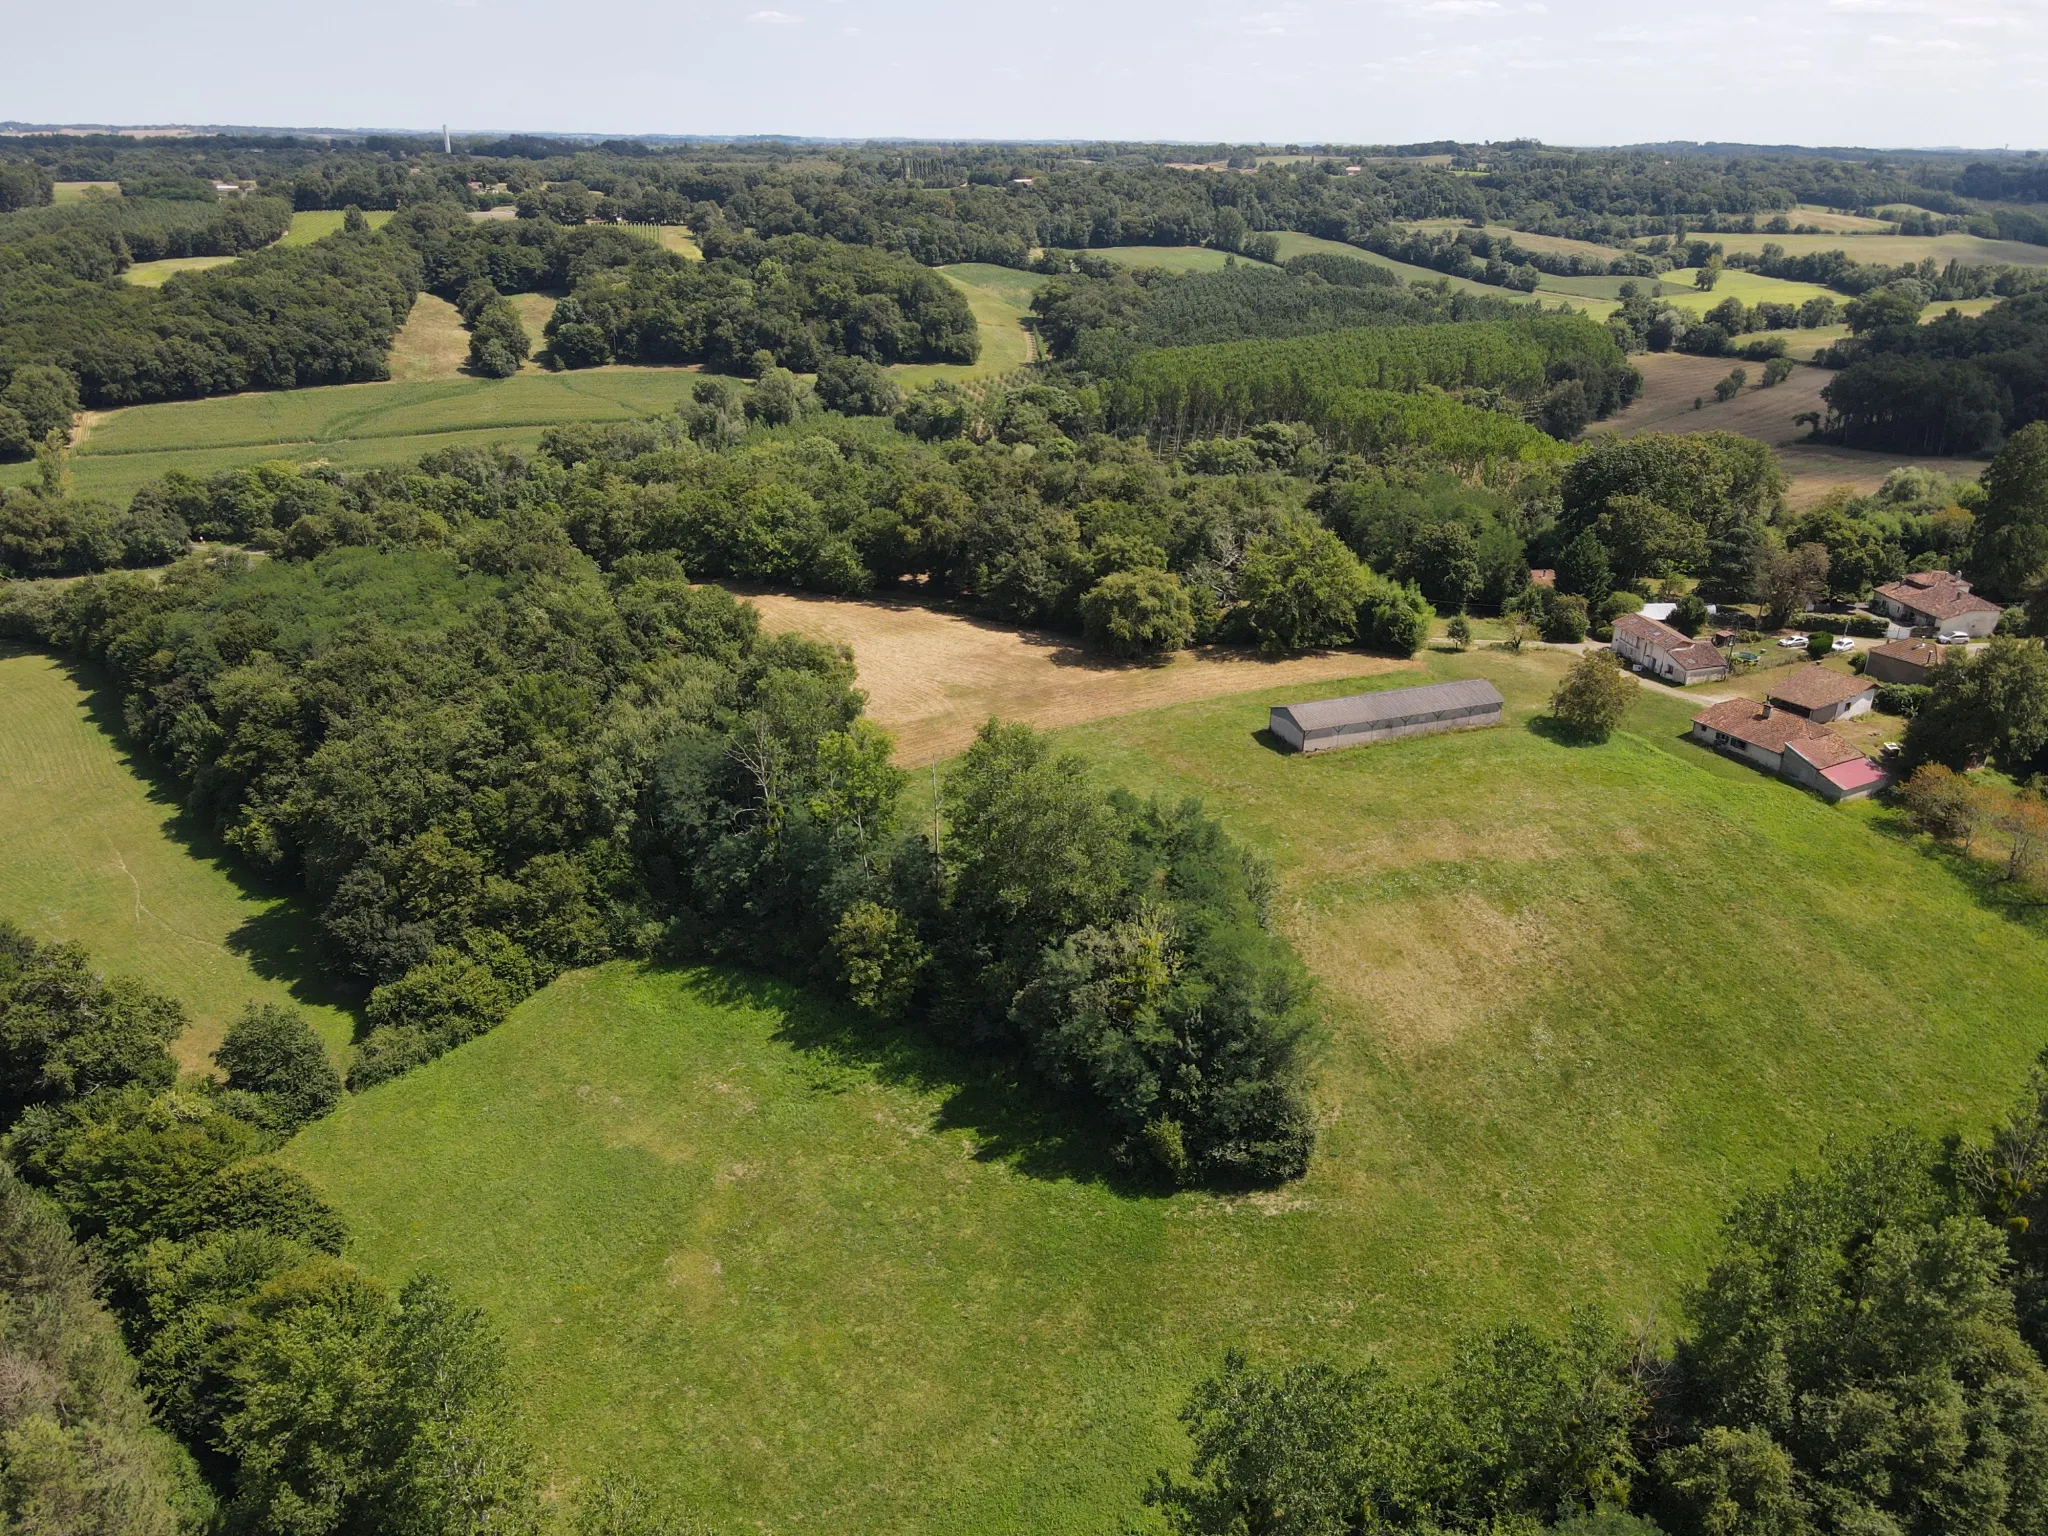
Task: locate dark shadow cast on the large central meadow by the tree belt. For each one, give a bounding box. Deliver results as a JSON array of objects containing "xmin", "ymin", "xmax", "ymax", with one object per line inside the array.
[{"xmin": 682, "ymin": 965, "xmax": 1161, "ymax": 1196}]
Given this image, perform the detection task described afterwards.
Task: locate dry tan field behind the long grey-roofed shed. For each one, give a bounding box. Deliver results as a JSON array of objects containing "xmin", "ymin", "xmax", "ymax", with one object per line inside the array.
[{"xmin": 739, "ymin": 590, "xmax": 1409, "ymax": 768}]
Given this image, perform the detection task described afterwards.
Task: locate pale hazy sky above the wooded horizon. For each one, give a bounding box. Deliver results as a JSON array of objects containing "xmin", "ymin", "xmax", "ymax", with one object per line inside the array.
[{"xmin": 12, "ymin": 0, "xmax": 2048, "ymax": 150}]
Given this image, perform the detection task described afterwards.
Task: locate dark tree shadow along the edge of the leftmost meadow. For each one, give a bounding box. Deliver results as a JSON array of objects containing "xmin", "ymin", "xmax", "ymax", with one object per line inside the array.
[{"xmin": 37, "ymin": 645, "xmax": 365, "ymax": 1032}]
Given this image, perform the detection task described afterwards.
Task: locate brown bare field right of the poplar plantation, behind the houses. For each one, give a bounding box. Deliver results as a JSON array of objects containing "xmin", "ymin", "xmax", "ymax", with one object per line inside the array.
[{"xmin": 1587, "ymin": 352, "xmax": 1985, "ymax": 508}]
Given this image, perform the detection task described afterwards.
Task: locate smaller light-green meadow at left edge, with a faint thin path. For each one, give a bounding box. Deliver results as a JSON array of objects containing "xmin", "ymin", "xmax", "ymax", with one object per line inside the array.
[{"xmin": 0, "ymin": 641, "xmax": 352, "ymax": 1069}]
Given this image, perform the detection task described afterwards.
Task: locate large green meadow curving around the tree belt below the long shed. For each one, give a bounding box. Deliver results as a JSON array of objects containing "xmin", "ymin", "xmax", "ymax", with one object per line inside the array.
[{"xmin": 289, "ymin": 651, "xmax": 2048, "ymax": 1536}]
